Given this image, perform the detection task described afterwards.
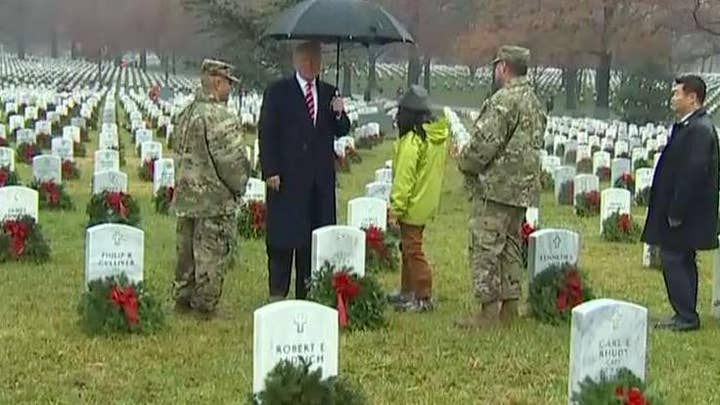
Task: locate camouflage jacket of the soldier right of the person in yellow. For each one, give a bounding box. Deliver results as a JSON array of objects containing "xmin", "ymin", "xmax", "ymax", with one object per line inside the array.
[{"xmin": 458, "ymin": 77, "xmax": 547, "ymax": 207}]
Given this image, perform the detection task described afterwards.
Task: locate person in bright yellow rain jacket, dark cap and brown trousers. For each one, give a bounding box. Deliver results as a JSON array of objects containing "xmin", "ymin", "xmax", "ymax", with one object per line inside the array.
[{"xmin": 390, "ymin": 85, "xmax": 449, "ymax": 312}]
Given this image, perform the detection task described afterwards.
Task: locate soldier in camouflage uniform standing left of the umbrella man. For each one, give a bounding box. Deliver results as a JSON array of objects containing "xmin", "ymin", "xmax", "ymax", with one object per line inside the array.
[{"xmin": 173, "ymin": 60, "xmax": 250, "ymax": 317}]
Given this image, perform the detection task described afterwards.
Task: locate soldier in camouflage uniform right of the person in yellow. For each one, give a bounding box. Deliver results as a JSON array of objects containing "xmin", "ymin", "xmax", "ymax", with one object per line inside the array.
[{"xmin": 457, "ymin": 46, "xmax": 547, "ymax": 327}]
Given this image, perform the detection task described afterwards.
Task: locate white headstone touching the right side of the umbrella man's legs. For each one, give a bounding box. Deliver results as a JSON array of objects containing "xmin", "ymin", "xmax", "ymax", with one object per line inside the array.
[{"xmin": 311, "ymin": 225, "xmax": 365, "ymax": 277}]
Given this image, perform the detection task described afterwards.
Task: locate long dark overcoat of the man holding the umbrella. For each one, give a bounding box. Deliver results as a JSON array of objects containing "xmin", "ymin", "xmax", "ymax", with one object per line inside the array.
[{"xmin": 258, "ymin": 74, "xmax": 350, "ymax": 249}]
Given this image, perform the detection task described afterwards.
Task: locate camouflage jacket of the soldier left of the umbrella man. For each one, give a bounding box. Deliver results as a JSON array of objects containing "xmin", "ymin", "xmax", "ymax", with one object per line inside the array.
[{"xmin": 173, "ymin": 87, "xmax": 250, "ymax": 217}]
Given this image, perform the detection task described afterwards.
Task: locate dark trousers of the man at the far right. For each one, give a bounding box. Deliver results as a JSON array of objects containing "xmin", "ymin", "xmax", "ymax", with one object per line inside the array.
[{"xmin": 660, "ymin": 249, "xmax": 700, "ymax": 323}]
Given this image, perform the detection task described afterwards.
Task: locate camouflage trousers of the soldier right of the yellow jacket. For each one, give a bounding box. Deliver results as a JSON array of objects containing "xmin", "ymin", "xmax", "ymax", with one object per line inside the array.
[{"xmin": 468, "ymin": 199, "xmax": 525, "ymax": 304}]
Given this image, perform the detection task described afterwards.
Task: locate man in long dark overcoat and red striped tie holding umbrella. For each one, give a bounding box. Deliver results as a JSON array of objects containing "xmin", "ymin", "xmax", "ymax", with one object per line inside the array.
[{"xmin": 258, "ymin": 42, "xmax": 350, "ymax": 300}]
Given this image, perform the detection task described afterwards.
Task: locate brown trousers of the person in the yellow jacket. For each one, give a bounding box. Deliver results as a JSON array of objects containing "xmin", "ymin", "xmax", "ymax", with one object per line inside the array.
[{"xmin": 400, "ymin": 223, "xmax": 432, "ymax": 299}]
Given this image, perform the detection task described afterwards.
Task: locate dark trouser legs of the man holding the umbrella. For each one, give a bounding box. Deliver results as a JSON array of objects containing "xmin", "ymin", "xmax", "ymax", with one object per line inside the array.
[{"xmin": 267, "ymin": 246, "xmax": 311, "ymax": 300}]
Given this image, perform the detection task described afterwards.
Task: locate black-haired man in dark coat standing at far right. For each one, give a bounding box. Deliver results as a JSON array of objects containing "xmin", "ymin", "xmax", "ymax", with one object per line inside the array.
[{"xmin": 642, "ymin": 76, "xmax": 720, "ymax": 331}]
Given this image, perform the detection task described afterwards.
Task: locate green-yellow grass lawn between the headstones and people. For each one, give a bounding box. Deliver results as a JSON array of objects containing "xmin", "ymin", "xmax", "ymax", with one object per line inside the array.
[{"xmin": 0, "ymin": 110, "xmax": 720, "ymax": 405}]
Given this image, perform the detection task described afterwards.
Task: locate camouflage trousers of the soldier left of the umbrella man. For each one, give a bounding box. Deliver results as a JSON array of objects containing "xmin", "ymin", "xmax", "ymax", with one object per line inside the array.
[{"xmin": 173, "ymin": 216, "xmax": 237, "ymax": 312}]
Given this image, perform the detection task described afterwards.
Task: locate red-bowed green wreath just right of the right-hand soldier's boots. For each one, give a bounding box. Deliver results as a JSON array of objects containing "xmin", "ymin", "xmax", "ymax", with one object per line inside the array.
[{"xmin": 528, "ymin": 263, "xmax": 594, "ymax": 325}]
